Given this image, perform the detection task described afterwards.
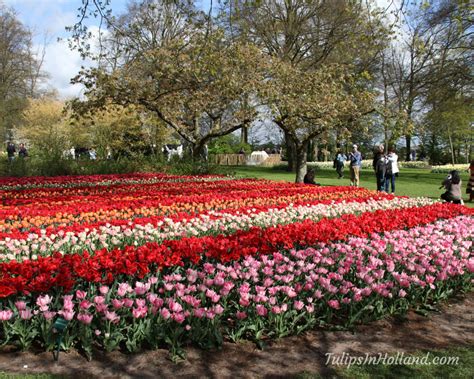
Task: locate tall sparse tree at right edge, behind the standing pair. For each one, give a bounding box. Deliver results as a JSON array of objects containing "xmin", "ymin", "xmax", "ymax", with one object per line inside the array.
[{"xmin": 383, "ymin": 0, "xmax": 473, "ymax": 160}]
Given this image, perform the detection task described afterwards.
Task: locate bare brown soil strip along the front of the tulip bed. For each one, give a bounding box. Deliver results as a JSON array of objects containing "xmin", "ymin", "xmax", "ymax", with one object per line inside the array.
[{"xmin": 0, "ymin": 292, "xmax": 474, "ymax": 378}]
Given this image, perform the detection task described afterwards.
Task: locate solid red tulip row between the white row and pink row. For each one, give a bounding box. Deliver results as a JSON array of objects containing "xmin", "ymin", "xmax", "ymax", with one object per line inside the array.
[{"xmin": 0, "ymin": 203, "xmax": 473, "ymax": 297}]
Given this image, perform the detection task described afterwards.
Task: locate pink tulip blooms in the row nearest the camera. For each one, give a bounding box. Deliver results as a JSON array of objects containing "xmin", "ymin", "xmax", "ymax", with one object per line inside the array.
[{"xmin": 0, "ymin": 216, "xmax": 474, "ymax": 350}]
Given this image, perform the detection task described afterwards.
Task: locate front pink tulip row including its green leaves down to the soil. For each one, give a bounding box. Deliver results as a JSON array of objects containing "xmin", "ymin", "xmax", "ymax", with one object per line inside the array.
[{"xmin": 0, "ymin": 217, "xmax": 474, "ymax": 356}]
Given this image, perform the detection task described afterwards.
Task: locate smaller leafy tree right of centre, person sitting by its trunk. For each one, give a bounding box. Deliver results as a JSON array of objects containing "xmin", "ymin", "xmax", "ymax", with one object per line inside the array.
[{"xmin": 261, "ymin": 60, "xmax": 373, "ymax": 183}]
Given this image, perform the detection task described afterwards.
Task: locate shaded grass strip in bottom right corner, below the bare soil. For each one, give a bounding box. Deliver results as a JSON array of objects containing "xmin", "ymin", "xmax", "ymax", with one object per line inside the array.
[{"xmin": 299, "ymin": 346, "xmax": 474, "ymax": 379}]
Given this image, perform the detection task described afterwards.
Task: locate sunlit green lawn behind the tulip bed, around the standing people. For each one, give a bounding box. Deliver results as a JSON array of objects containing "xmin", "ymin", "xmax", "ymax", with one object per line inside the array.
[{"xmin": 233, "ymin": 166, "xmax": 474, "ymax": 207}]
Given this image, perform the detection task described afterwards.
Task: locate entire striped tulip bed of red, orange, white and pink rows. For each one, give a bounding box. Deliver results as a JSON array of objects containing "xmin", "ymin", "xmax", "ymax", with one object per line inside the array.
[{"xmin": 0, "ymin": 174, "xmax": 474, "ymax": 357}]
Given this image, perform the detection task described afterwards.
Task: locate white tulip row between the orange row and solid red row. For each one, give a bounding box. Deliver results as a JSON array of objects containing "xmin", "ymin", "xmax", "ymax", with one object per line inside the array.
[{"xmin": 0, "ymin": 198, "xmax": 434, "ymax": 261}]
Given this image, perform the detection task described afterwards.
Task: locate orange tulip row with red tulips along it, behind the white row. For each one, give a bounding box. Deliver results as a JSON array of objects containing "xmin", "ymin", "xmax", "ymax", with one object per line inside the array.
[{"xmin": 0, "ymin": 183, "xmax": 380, "ymax": 238}]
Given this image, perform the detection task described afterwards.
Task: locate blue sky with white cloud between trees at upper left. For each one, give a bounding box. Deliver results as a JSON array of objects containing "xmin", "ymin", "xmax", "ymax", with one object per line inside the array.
[{"xmin": 0, "ymin": 0, "xmax": 397, "ymax": 99}]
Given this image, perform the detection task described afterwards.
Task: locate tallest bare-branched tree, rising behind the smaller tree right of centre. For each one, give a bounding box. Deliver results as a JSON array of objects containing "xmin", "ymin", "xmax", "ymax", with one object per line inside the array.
[{"xmin": 220, "ymin": 0, "xmax": 389, "ymax": 170}]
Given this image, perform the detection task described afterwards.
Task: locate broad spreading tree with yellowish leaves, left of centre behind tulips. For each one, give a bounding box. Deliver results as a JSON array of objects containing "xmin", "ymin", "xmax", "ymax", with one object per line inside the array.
[{"xmin": 74, "ymin": 30, "xmax": 265, "ymax": 159}]
